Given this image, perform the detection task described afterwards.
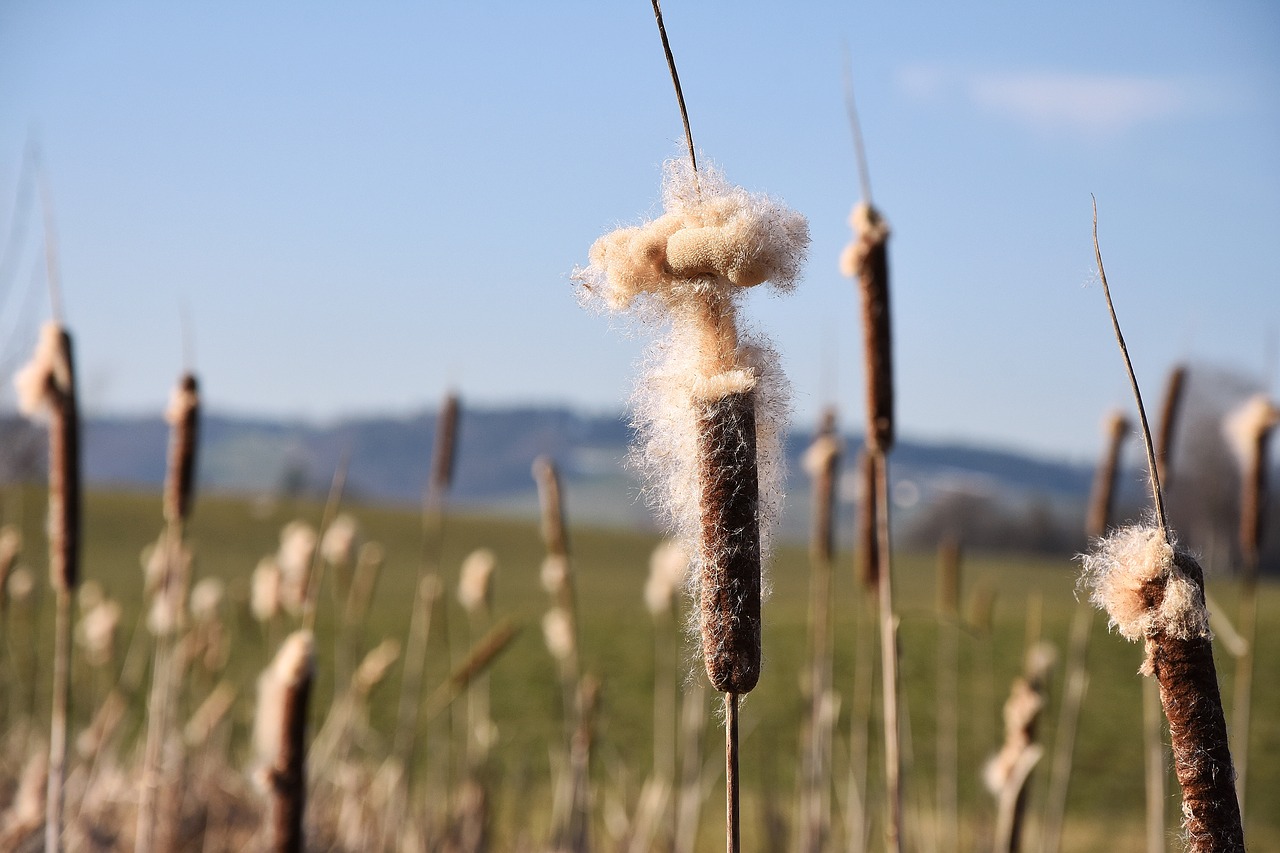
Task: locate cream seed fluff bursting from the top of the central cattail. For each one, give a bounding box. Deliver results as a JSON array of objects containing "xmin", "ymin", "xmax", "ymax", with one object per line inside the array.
[{"xmin": 573, "ymin": 159, "xmax": 809, "ymax": 650}]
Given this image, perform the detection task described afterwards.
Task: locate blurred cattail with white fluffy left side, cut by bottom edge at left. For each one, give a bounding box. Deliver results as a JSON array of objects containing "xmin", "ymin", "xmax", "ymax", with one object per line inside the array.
[{"xmin": 253, "ymin": 630, "xmax": 315, "ymax": 853}]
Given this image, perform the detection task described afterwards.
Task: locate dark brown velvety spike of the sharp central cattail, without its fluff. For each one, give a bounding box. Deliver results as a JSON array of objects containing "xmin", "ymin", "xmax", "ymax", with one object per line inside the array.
[{"xmin": 698, "ymin": 391, "xmax": 760, "ymax": 694}]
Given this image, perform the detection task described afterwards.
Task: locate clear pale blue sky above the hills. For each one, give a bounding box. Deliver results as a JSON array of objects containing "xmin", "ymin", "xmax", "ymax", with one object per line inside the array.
[{"xmin": 0, "ymin": 0, "xmax": 1280, "ymax": 459}]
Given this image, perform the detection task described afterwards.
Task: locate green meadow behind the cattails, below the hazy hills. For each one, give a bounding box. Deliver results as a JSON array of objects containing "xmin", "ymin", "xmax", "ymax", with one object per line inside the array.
[{"xmin": 0, "ymin": 488, "xmax": 1280, "ymax": 850}]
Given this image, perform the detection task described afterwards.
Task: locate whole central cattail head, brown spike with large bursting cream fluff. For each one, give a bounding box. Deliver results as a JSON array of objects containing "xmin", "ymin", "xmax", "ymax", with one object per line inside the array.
[{"xmin": 573, "ymin": 160, "xmax": 809, "ymax": 694}]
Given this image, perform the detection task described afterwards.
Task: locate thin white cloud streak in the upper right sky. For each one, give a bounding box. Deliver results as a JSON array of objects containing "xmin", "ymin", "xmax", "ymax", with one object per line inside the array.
[{"xmin": 897, "ymin": 64, "xmax": 1213, "ymax": 137}]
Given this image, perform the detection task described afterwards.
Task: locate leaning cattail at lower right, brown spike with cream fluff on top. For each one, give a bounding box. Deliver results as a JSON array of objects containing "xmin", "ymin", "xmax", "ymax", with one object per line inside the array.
[{"xmin": 1083, "ymin": 525, "xmax": 1244, "ymax": 853}]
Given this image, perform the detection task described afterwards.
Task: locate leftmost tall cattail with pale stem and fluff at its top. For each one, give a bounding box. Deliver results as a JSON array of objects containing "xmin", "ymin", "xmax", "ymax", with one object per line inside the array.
[{"xmin": 15, "ymin": 320, "xmax": 81, "ymax": 853}]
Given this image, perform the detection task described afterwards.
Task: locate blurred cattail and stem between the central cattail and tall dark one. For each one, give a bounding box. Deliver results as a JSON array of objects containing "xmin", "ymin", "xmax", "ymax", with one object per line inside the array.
[{"xmin": 796, "ymin": 410, "xmax": 840, "ymax": 850}]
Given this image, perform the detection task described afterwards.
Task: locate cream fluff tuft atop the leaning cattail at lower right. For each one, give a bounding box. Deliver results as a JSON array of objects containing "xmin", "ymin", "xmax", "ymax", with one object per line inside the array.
[{"xmin": 1080, "ymin": 523, "xmax": 1211, "ymax": 675}]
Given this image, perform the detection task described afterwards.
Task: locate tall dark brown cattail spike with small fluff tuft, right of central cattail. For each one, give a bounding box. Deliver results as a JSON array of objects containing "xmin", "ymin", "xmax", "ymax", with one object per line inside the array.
[{"xmin": 840, "ymin": 201, "xmax": 893, "ymax": 453}]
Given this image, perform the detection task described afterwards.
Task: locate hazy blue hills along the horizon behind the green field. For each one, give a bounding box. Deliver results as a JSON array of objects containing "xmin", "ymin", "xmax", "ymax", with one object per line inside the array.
[{"xmin": 52, "ymin": 406, "xmax": 1121, "ymax": 534}]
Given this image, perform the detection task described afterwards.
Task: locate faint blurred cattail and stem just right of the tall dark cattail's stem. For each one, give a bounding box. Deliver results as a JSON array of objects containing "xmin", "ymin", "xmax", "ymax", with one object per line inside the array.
[{"xmin": 936, "ymin": 537, "xmax": 960, "ymax": 849}]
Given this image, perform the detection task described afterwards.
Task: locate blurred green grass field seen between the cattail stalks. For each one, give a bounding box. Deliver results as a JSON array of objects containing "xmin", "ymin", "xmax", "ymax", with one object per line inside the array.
[{"xmin": 4, "ymin": 481, "xmax": 1280, "ymax": 850}]
